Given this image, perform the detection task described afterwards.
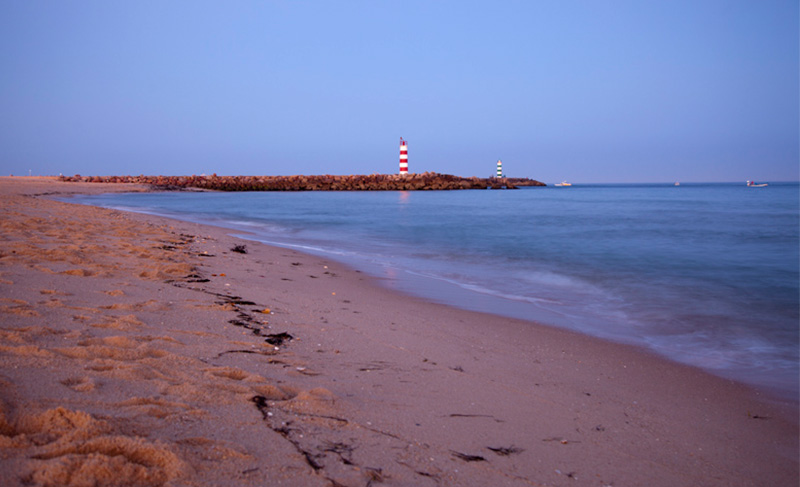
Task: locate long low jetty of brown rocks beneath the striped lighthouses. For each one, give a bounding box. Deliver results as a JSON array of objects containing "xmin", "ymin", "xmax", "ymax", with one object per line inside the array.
[{"xmin": 60, "ymin": 172, "xmax": 545, "ymax": 191}]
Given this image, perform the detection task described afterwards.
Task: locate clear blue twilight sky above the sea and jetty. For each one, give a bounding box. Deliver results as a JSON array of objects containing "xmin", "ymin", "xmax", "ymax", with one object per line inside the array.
[{"xmin": 0, "ymin": 0, "xmax": 800, "ymax": 183}]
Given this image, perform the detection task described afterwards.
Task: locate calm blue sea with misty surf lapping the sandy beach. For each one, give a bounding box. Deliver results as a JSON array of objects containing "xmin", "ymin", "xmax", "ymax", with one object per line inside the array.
[{"xmin": 73, "ymin": 183, "xmax": 800, "ymax": 399}]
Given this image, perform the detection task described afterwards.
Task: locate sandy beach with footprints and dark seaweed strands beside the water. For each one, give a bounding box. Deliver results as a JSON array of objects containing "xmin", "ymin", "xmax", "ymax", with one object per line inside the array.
[{"xmin": 0, "ymin": 178, "xmax": 798, "ymax": 486}]
